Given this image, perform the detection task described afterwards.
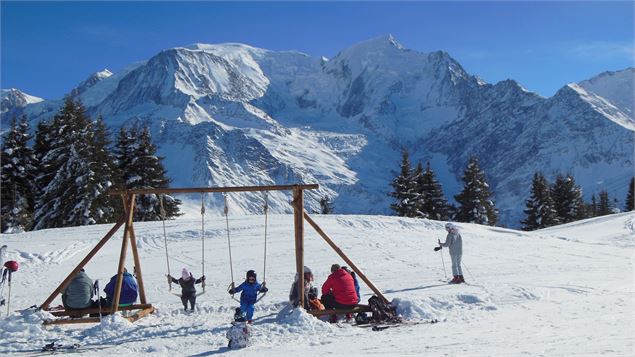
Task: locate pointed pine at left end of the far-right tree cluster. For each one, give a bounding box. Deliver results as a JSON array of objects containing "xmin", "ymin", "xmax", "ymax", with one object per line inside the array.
[{"xmin": 520, "ymin": 172, "xmax": 558, "ymax": 231}]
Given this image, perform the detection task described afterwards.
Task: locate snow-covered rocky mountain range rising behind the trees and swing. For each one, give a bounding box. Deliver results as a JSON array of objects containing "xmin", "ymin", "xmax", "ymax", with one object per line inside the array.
[{"xmin": 1, "ymin": 36, "xmax": 635, "ymax": 225}]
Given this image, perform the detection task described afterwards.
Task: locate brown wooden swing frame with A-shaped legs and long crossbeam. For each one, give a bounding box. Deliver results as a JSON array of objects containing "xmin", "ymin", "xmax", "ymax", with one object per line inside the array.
[{"xmin": 40, "ymin": 184, "xmax": 388, "ymax": 325}]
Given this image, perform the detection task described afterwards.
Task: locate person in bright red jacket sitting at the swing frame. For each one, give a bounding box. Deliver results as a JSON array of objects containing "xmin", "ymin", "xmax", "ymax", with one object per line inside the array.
[{"xmin": 321, "ymin": 264, "xmax": 358, "ymax": 309}]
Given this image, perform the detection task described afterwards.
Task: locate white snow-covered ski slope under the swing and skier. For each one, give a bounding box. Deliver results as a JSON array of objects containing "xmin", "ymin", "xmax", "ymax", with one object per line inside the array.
[{"xmin": 0, "ymin": 212, "xmax": 635, "ymax": 357}]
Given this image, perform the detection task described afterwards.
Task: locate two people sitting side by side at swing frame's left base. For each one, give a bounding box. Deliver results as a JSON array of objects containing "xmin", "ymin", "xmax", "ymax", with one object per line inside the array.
[{"xmin": 62, "ymin": 268, "xmax": 139, "ymax": 310}]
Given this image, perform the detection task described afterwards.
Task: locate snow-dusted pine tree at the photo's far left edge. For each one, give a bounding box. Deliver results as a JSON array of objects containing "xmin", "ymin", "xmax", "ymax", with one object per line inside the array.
[{"xmin": 0, "ymin": 117, "xmax": 35, "ymax": 233}]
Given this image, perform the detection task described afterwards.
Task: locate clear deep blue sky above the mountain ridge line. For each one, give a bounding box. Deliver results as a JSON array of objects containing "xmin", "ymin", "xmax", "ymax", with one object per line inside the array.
[{"xmin": 0, "ymin": 1, "xmax": 635, "ymax": 99}]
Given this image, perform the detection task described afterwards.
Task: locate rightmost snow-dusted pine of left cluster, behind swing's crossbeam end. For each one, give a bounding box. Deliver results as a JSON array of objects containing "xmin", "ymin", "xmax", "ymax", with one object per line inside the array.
[{"xmin": 116, "ymin": 127, "xmax": 181, "ymax": 221}]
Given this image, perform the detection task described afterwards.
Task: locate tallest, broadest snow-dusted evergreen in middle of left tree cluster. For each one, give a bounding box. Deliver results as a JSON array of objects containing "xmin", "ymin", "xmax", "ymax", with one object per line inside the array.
[{"xmin": 34, "ymin": 97, "xmax": 118, "ymax": 229}]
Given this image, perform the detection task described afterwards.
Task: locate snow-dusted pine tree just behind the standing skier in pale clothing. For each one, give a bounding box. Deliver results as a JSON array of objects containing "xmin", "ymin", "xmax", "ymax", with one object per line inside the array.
[{"xmin": 454, "ymin": 156, "xmax": 498, "ymax": 226}]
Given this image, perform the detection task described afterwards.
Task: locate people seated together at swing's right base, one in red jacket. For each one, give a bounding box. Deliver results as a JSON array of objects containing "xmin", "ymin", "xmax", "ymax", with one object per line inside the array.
[{"xmin": 289, "ymin": 264, "xmax": 361, "ymax": 318}]
